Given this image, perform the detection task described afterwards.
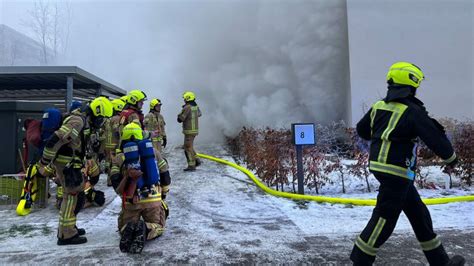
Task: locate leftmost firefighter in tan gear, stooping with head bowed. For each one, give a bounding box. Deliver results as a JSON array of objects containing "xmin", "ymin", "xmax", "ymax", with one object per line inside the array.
[{"xmin": 37, "ymin": 97, "xmax": 112, "ymax": 245}]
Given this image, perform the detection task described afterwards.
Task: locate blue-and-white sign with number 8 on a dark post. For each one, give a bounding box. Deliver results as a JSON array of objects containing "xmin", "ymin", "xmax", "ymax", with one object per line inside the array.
[{"xmin": 291, "ymin": 123, "xmax": 316, "ymax": 194}]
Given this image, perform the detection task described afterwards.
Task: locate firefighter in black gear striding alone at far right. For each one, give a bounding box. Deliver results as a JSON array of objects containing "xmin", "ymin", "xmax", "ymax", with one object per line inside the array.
[{"xmin": 351, "ymin": 62, "xmax": 464, "ymax": 265}]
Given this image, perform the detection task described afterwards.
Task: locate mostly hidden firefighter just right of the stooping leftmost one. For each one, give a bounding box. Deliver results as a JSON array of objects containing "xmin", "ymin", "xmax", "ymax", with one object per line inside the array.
[{"xmin": 104, "ymin": 96, "xmax": 126, "ymax": 187}]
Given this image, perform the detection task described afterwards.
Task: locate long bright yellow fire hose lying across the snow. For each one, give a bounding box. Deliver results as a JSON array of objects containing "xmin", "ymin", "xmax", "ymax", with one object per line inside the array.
[{"xmin": 197, "ymin": 153, "xmax": 474, "ymax": 206}]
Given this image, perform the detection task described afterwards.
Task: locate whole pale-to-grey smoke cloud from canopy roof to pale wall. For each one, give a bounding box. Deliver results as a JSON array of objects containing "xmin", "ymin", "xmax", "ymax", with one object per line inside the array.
[{"xmin": 57, "ymin": 0, "xmax": 350, "ymax": 141}]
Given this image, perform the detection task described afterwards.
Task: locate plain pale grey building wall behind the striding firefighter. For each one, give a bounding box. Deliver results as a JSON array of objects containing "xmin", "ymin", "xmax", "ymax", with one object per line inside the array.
[{"xmin": 348, "ymin": 0, "xmax": 474, "ymax": 122}]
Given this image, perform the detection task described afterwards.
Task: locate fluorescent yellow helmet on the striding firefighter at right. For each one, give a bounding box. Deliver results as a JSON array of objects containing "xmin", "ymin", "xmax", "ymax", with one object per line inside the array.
[{"xmin": 387, "ymin": 62, "xmax": 425, "ymax": 88}]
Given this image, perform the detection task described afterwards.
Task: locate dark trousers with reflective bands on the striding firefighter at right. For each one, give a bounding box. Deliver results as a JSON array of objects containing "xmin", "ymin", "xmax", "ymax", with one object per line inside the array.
[{"xmin": 351, "ymin": 173, "xmax": 449, "ymax": 265}]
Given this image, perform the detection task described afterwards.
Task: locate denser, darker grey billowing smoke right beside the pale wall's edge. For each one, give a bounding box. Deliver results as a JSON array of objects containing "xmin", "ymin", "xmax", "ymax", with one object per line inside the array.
[{"xmin": 200, "ymin": 1, "xmax": 350, "ymax": 139}]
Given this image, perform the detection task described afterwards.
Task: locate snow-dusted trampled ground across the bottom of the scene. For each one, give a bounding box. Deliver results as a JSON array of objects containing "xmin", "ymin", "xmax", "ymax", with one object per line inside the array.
[{"xmin": 0, "ymin": 146, "xmax": 474, "ymax": 264}]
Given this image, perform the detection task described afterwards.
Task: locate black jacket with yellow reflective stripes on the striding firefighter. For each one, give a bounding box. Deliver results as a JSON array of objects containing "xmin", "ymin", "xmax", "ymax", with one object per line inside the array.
[{"xmin": 357, "ymin": 85, "xmax": 456, "ymax": 180}]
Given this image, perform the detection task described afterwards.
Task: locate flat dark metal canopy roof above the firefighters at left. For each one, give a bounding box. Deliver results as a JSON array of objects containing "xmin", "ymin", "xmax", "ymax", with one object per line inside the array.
[{"xmin": 0, "ymin": 66, "xmax": 126, "ymax": 109}]
